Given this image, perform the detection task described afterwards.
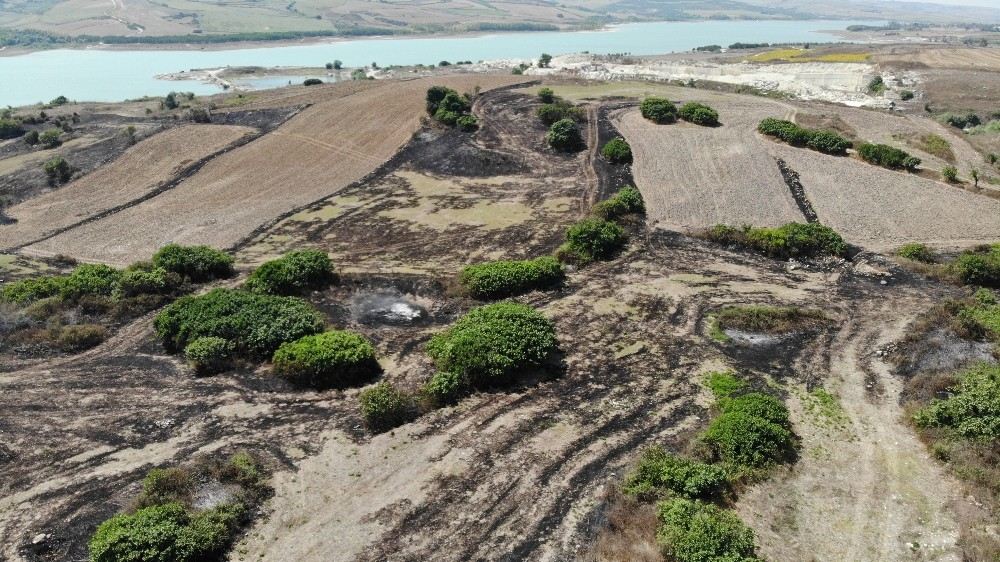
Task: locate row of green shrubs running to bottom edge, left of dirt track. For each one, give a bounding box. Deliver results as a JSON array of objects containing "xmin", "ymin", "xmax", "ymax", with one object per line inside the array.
[{"xmin": 622, "ymin": 373, "xmax": 795, "ymax": 562}]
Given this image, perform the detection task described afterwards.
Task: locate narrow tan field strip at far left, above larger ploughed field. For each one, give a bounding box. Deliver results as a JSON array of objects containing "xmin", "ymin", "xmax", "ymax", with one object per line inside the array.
[{"xmin": 0, "ymin": 125, "xmax": 254, "ymax": 247}]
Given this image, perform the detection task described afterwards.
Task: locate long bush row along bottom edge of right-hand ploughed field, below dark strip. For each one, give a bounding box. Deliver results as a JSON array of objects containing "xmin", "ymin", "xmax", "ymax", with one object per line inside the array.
[{"xmin": 706, "ymin": 222, "xmax": 848, "ymax": 259}]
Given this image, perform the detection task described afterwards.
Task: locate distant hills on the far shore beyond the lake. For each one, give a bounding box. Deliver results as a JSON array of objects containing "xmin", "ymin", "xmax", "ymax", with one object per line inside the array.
[{"xmin": 0, "ymin": 0, "xmax": 1000, "ymax": 46}]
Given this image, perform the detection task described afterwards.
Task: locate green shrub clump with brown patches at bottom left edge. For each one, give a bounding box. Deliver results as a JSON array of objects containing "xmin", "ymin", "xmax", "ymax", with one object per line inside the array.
[{"xmin": 88, "ymin": 452, "xmax": 270, "ymax": 562}]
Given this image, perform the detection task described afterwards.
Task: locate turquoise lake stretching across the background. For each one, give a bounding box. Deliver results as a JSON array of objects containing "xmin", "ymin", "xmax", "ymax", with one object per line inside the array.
[{"xmin": 0, "ymin": 21, "xmax": 883, "ymax": 106}]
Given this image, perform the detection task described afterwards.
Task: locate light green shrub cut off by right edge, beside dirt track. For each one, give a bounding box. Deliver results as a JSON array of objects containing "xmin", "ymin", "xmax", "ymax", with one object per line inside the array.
[{"xmin": 914, "ymin": 363, "xmax": 1000, "ymax": 440}]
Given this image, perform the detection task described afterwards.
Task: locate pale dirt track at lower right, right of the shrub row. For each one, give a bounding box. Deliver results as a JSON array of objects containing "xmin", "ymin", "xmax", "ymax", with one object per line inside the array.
[{"xmin": 739, "ymin": 286, "xmax": 964, "ymax": 562}]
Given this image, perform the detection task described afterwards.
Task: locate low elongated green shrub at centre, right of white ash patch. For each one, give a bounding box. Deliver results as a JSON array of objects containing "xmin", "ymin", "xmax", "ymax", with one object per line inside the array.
[{"xmin": 459, "ymin": 256, "xmax": 566, "ymax": 299}]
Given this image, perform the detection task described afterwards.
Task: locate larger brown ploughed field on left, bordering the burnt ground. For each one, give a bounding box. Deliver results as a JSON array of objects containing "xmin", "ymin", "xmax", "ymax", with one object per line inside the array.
[{"xmin": 28, "ymin": 75, "xmax": 521, "ymax": 264}]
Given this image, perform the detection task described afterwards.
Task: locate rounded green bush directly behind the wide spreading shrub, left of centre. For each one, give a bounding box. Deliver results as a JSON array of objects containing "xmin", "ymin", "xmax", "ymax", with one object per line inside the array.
[{"xmin": 245, "ymin": 250, "xmax": 335, "ymax": 295}]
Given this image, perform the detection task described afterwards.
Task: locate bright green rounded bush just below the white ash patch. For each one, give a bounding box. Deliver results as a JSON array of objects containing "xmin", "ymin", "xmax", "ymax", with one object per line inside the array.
[{"xmin": 273, "ymin": 330, "xmax": 380, "ymax": 388}]
